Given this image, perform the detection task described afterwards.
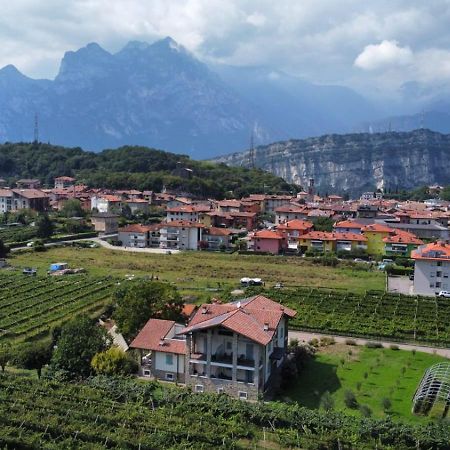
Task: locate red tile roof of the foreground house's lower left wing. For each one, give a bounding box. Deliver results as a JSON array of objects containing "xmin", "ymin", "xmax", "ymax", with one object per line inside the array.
[{"xmin": 130, "ymin": 319, "xmax": 186, "ymax": 355}]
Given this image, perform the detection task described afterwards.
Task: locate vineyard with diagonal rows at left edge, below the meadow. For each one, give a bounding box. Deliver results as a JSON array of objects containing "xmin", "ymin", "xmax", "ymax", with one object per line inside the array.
[{"xmin": 0, "ymin": 275, "xmax": 114, "ymax": 341}]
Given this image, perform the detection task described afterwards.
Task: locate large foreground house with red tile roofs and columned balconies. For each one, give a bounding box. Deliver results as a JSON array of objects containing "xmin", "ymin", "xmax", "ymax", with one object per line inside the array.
[{"xmin": 130, "ymin": 295, "xmax": 296, "ymax": 400}]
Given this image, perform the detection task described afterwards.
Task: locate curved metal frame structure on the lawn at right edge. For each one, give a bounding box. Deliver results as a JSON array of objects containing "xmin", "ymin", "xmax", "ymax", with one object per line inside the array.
[{"xmin": 413, "ymin": 362, "xmax": 450, "ymax": 418}]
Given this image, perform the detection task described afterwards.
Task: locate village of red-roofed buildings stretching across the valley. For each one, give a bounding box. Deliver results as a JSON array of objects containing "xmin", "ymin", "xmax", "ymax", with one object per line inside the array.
[{"xmin": 0, "ymin": 176, "xmax": 450, "ymax": 296}]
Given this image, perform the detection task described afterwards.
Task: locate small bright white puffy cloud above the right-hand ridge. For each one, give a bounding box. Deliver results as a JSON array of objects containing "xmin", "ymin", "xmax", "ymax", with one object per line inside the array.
[{"xmin": 354, "ymin": 40, "xmax": 414, "ymax": 70}]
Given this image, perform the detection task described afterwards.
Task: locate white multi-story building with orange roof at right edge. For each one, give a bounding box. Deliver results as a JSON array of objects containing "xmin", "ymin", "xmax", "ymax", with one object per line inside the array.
[{"xmin": 411, "ymin": 241, "xmax": 450, "ymax": 295}]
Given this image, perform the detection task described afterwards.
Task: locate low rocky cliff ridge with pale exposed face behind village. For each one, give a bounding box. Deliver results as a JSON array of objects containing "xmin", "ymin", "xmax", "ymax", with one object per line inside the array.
[{"xmin": 213, "ymin": 129, "xmax": 450, "ymax": 197}]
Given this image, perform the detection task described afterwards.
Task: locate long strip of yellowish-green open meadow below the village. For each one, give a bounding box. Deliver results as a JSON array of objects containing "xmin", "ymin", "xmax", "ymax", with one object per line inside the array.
[{"xmin": 10, "ymin": 247, "xmax": 384, "ymax": 298}]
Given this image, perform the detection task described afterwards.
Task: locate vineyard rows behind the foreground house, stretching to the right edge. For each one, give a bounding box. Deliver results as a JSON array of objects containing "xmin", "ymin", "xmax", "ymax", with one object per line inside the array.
[{"xmin": 267, "ymin": 287, "xmax": 450, "ymax": 345}]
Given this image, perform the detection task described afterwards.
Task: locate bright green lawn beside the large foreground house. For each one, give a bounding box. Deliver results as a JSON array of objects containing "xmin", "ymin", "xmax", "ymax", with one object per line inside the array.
[{"xmin": 284, "ymin": 344, "xmax": 448, "ymax": 423}]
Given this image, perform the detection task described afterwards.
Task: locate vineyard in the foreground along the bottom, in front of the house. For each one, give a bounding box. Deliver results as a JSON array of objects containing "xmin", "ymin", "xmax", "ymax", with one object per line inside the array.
[{"xmin": 0, "ymin": 375, "xmax": 450, "ymax": 450}]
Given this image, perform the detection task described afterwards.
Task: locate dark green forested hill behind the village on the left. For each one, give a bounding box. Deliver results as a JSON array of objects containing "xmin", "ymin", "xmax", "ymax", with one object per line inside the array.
[{"xmin": 0, "ymin": 143, "xmax": 294, "ymax": 198}]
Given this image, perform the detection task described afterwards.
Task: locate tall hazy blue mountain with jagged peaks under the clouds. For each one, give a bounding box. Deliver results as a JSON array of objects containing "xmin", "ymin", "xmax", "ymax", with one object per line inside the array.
[{"xmin": 0, "ymin": 37, "xmax": 378, "ymax": 158}]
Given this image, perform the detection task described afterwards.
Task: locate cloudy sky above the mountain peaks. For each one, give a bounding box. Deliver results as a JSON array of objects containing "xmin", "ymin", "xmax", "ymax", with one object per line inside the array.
[{"xmin": 0, "ymin": 0, "xmax": 450, "ymax": 96}]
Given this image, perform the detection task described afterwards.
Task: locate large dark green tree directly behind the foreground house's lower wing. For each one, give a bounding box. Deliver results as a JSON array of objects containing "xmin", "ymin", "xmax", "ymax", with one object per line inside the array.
[{"xmin": 113, "ymin": 280, "xmax": 183, "ymax": 338}]
